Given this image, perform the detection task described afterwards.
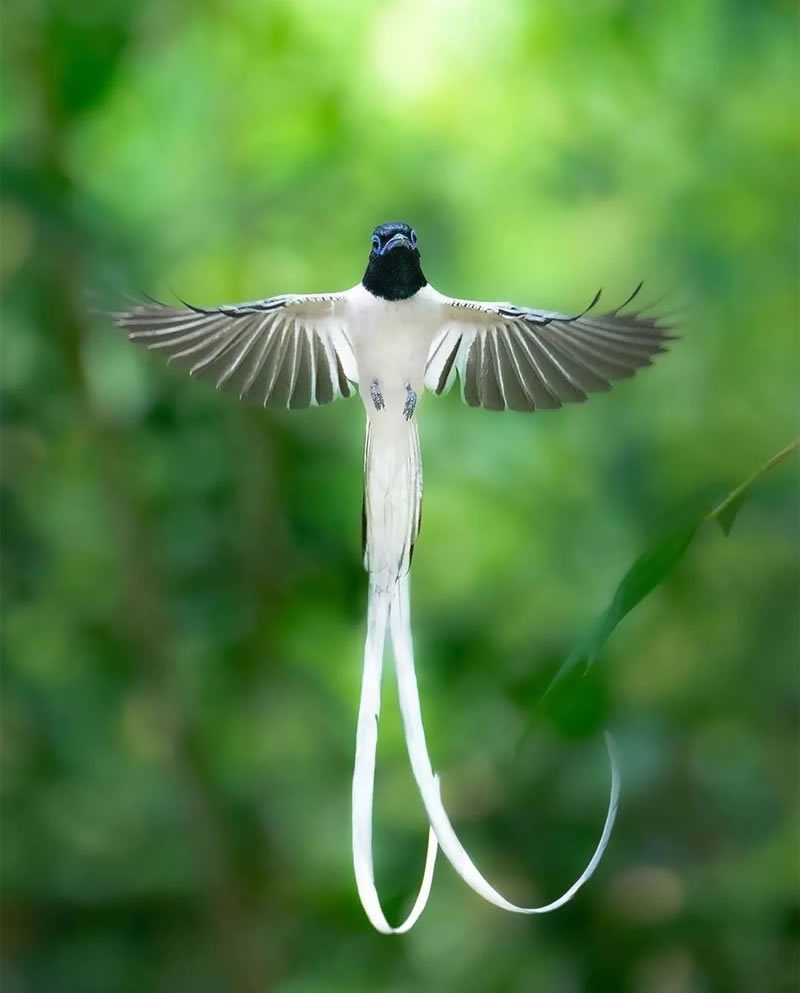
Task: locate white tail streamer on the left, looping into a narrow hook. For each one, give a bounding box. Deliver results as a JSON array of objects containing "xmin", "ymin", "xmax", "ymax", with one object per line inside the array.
[{"xmin": 352, "ymin": 583, "xmax": 437, "ymax": 934}]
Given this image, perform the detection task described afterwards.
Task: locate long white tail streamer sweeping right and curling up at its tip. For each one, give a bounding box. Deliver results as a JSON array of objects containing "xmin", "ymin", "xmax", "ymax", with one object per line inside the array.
[{"xmin": 389, "ymin": 574, "xmax": 620, "ymax": 914}]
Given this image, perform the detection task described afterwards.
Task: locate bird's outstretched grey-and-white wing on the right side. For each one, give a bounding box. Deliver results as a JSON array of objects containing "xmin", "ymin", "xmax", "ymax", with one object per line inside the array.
[{"xmin": 425, "ymin": 283, "xmax": 675, "ymax": 411}]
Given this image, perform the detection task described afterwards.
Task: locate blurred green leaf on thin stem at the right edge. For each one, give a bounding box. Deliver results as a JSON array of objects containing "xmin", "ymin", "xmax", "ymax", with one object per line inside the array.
[{"xmin": 544, "ymin": 439, "xmax": 800, "ymax": 697}]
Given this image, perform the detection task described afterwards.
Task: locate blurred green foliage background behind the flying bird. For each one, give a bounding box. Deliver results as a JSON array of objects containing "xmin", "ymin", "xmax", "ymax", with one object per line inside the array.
[{"xmin": 0, "ymin": 0, "xmax": 800, "ymax": 993}]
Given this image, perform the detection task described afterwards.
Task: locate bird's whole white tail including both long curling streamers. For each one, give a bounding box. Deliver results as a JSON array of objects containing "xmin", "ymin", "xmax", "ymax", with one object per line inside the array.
[{"xmin": 353, "ymin": 410, "xmax": 619, "ymax": 933}]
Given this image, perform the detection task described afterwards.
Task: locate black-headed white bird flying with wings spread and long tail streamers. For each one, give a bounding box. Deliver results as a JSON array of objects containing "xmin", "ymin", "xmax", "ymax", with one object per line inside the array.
[{"xmin": 111, "ymin": 221, "xmax": 675, "ymax": 934}]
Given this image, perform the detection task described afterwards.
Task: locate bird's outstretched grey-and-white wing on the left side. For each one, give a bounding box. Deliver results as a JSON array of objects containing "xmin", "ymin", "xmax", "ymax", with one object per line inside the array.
[{"xmin": 112, "ymin": 294, "xmax": 358, "ymax": 407}]
